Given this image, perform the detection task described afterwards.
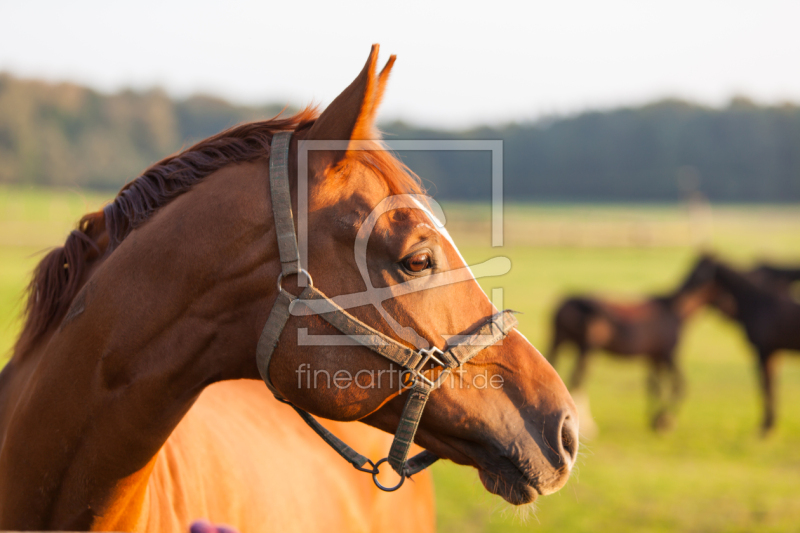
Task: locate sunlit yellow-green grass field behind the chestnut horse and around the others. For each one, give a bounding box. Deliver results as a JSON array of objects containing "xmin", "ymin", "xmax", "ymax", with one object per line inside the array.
[{"xmin": 0, "ymin": 188, "xmax": 800, "ymax": 533}]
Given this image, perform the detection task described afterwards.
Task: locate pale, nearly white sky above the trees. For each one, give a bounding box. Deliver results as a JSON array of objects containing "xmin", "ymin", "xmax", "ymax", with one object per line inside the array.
[{"xmin": 0, "ymin": 0, "xmax": 800, "ymax": 128}]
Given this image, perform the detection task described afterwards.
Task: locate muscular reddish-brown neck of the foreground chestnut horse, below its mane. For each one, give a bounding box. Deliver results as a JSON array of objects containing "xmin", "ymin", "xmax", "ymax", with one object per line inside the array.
[{"xmin": 0, "ymin": 163, "xmax": 279, "ymax": 530}]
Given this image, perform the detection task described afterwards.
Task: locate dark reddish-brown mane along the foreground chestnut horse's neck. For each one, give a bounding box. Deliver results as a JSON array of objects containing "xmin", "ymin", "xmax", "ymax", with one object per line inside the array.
[{"xmin": 13, "ymin": 107, "xmax": 319, "ymax": 357}]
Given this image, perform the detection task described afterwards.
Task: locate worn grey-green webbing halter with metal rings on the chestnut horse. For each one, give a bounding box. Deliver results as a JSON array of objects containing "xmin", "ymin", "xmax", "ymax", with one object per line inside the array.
[{"xmin": 256, "ymin": 131, "xmax": 517, "ymax": 492}]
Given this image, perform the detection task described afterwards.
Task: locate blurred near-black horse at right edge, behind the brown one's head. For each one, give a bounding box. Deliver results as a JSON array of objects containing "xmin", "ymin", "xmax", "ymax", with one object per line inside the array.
[{"xmin": 712, "ymin": 256, "xmax": 800, "ymax": 433}]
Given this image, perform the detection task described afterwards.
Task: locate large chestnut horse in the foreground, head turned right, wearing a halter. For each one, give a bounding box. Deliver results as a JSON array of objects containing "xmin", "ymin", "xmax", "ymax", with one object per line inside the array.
[{"xmin": 0, "ymin": 46, "xmax": 577, "ymax": 533}]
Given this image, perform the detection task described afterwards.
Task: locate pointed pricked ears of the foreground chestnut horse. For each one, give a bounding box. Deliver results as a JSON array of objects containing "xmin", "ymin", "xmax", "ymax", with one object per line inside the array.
[{"xmin": 304, "ymin": 44, "xmax": 395, "ymax": 170}]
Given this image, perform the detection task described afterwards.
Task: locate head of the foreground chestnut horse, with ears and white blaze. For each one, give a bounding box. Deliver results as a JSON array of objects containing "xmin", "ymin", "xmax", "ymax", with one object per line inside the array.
[{"xmin": 269, "ymin": 46, "xmax": 578, "ymax": 504}]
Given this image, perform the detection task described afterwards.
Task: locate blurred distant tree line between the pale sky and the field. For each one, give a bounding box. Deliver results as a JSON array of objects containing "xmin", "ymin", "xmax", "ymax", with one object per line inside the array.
[{"xmin": 0, "ymin": 74, "xmax": 800, "ymax": 202}]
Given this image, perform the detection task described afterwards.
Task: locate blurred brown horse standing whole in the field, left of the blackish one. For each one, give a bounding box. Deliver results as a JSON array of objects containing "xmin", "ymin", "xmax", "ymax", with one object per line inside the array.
[{"xmin": 548, "ymin": 258, "xmax": 713, "ymax": 429}]
